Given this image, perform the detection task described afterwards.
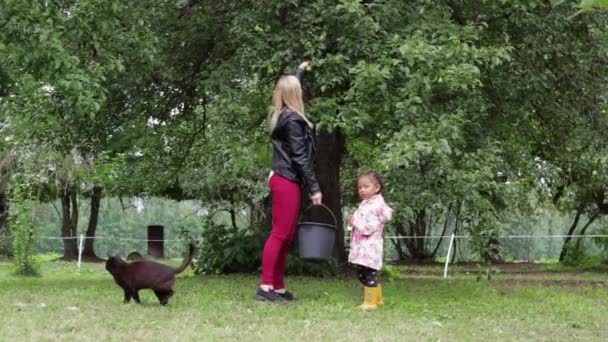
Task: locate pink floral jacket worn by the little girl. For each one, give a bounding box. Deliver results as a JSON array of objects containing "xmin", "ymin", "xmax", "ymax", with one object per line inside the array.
[{"xmin": 348, "ymin": 194, "xmax": 393, "ymax": 270}]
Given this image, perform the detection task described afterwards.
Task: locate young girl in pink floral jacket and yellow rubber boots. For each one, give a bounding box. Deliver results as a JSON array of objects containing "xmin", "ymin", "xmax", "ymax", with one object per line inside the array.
[{"xmin": 347, "ymin": 171, "xmax": 393, "ymax": 309}]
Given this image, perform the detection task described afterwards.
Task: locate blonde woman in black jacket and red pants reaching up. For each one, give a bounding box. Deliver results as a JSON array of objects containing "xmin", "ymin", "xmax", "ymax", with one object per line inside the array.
[{"xmin": 256, "ymin": 62, "xmax": 323, "ymax": 302}]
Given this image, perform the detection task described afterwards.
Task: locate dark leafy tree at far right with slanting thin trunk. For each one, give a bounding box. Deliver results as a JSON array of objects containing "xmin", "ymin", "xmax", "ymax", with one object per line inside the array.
[{"xmin": 472, "ymin": 0, "xmax": 606, "ymax": 260}]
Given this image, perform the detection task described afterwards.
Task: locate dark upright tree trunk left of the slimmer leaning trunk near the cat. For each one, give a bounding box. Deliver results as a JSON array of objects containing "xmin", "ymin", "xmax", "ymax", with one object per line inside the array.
[{"xmin": 61, "ymin": 186, "xmax": 78, "ymax": 260}]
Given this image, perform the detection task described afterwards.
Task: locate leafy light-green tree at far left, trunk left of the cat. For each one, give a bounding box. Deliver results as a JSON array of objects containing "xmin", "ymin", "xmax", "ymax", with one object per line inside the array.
[{"xmin": 0, "ymin": 0, "xmax": 160, "ymax": 259}]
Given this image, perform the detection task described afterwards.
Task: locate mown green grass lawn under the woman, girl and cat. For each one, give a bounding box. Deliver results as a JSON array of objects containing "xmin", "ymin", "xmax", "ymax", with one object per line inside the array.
[{"xmin": 0, "ymin": 261, "xmax": 608, "ymax": 341}]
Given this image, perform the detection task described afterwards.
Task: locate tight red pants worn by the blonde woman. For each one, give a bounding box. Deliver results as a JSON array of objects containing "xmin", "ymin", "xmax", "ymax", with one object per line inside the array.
[{"xmin": 262, "ymin": 173, "xmax": 300, "ymax": 289}]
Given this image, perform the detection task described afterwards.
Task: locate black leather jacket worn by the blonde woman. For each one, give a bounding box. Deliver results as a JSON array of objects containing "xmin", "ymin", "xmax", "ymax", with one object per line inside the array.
[{"xmin": 271, "ymin": 109, "xmax": 321, "ymax": 194}]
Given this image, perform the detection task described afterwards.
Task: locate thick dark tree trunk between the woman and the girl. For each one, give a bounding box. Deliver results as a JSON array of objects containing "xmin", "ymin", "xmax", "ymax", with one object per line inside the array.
[{"xmin": 312, "ymin": 129, "xmax": 347, "ymax": 265}]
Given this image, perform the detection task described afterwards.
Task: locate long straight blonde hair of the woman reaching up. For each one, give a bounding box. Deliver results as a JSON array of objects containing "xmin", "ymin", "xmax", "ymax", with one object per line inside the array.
[{"xmin": 269, "ymin": 75, "xmax": 312, "ymax": 132}]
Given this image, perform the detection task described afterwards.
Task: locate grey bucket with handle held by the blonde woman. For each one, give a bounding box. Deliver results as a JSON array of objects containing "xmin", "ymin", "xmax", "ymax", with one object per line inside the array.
[{"xmin": 298, "ymin": 204, "xmax": 338, "ymax": 260}]
